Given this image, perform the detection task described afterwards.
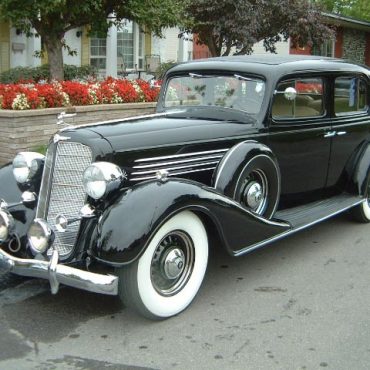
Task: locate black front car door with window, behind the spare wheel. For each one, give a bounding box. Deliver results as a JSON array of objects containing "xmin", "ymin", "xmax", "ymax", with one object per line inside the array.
[{"xmin": 268, "ymin": 76, "xmax": 331, "ymax": 203}]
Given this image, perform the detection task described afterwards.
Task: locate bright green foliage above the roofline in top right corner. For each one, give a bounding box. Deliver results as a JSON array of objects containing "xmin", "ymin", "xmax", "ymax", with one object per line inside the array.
[{"xmin": 316, "ymin": 0, "xmax": 370, "ymax": 21}]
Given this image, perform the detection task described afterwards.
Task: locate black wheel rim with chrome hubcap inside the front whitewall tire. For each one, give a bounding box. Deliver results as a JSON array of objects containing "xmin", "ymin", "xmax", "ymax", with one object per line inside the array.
[{"xmin": 150, "ymin": 230, "xmax": 195, "ymax": 296}]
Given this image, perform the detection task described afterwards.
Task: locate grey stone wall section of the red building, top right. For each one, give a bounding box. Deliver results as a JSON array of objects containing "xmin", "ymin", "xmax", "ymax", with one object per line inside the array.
[{"xmin": 343, "ymin": 29, "xmax": 366, "ymax": 64}]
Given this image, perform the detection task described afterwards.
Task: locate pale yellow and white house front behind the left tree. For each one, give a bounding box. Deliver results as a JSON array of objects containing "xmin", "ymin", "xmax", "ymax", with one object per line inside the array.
[{"xmin": 0, "ymin": 21, "xmax": 192, "ymax": 77}]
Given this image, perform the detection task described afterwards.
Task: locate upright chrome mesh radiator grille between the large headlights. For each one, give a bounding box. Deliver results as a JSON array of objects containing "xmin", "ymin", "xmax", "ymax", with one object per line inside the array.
[{"xmin": 37, "ymin": 141, "xmax": 92, "ymax": 257}]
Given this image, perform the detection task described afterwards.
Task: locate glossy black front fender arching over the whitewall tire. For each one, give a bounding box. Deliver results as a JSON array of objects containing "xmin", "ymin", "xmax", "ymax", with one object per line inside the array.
[{"xmin": 92, "ymin": 179, "xmax": 290, "ymax": 266}]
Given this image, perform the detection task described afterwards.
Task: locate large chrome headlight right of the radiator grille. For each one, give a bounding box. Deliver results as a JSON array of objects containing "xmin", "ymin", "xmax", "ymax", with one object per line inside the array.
[{"xmin": 83, "ymin": 162, "xmax": 123, "ymax": 199}]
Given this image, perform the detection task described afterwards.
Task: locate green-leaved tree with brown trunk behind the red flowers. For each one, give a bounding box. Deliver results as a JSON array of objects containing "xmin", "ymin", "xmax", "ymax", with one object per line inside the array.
[{"xmin": 0, "ymin": 0, "xmax": 179, "ymax": 80}]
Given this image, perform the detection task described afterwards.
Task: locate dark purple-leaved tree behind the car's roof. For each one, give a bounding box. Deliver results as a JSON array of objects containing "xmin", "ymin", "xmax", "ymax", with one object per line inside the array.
[{"xmin": 183, "ymin": 0, "xmax": 334, "ymax": 56}]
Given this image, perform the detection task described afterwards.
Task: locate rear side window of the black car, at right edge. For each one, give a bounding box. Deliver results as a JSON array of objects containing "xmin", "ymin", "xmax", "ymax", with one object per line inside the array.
[{"xmin": 334, "ymin": 77, "xmax": 367, "ymax": 116}]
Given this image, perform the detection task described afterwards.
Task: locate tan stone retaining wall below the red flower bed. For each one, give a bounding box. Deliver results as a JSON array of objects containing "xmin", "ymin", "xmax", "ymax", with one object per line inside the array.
[{"xmin": 0, "ymin": 103, "xmax": 156, "ymax": 166}]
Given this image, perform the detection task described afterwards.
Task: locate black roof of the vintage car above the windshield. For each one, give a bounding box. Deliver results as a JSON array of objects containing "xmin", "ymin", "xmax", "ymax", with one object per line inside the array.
[{"xmin": 169, "ymin": 54, "xmax": 369, "ymax": 78}]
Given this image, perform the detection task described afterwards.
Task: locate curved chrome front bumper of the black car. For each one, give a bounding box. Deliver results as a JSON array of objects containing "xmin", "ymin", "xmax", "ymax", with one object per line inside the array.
[{"xmin": 0, "ymin": 248, "xmax": 118, "ymax": 295}]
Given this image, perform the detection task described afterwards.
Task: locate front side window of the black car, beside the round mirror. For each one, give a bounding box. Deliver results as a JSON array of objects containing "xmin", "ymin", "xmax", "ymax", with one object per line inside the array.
[{"xmin": 272, "ymin": 78, "xmax": 325, "ymax": 119}]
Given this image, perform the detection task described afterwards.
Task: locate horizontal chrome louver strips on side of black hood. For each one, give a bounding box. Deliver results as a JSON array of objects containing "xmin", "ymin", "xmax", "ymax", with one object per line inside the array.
[{"xmin": 130, "ymin": 149, "xmax": 228, "ymax": 181}]
